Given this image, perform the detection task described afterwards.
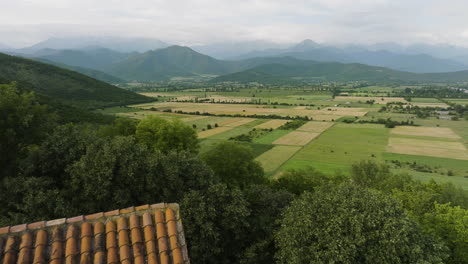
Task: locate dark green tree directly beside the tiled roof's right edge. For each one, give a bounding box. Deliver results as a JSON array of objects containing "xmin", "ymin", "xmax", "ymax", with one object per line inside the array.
[{"xmin": 180, "ymin": 184, "xmax": 250, "ymax": 264}]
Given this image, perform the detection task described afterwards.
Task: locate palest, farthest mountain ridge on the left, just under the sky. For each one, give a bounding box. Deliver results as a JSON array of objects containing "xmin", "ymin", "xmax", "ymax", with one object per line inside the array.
[{"xmin": 18, "ymin": 37, "xmax": 169, "ymax": 53}]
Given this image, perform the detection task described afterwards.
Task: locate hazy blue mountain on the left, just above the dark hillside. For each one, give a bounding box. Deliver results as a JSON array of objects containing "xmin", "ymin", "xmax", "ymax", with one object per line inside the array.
[{"xmin": 32, "ymin": 48, "xmax": 132, "ymax": 70}]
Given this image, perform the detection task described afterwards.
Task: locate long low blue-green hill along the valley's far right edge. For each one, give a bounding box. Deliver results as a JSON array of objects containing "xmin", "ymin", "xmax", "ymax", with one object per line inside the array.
[{"xmin": 212, "ymin": 61, "xmax": 468, "ymax": 83}]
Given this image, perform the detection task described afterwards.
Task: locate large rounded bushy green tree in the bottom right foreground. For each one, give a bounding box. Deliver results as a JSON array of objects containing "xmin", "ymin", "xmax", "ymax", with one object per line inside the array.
[{"xmin": 276, "ymin": 185, "xmax": 446, "ymax": 264}]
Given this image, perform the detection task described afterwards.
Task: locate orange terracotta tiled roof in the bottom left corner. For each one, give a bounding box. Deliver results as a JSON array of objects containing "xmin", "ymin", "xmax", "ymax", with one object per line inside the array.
[{"xmin": 0, "ymin": 203, "xmax": 189, "ymax": 264}]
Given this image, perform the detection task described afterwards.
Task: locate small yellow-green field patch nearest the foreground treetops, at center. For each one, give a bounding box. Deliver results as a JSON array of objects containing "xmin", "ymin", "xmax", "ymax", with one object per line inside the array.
[{"xmin": 256, "ymin": 146, "xmax": 301, "ymax": 173}]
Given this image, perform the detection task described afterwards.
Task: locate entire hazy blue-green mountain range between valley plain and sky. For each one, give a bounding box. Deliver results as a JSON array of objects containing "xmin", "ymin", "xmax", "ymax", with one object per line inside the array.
[{"xmin": 2, "ymin": 40, "xmax": 468, "ymax": 83}]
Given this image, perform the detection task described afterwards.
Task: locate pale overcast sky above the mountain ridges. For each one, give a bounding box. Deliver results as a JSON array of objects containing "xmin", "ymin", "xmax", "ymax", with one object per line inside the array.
[{"xmin": 0, "ymin": 0, "xmax": 468, "ymax": 47}]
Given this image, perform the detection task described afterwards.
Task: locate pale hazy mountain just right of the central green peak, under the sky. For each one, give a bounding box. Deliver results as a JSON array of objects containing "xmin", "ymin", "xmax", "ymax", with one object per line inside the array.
[{"xmin": 190, "ymin": 40, "xmax": 290, "ymax": 59}]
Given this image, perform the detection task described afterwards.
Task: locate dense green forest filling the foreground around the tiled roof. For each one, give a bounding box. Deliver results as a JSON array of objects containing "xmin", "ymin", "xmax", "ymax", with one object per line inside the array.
[{"xmin": 0, "ymin": 81, "xmax": 468, "ymax": 263}]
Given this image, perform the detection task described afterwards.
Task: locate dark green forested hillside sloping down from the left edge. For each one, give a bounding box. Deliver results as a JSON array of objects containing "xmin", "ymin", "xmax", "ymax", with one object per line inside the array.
[{"xmin": 0, "ymin": 53, "xmax": 151, "ymax": 109}]
